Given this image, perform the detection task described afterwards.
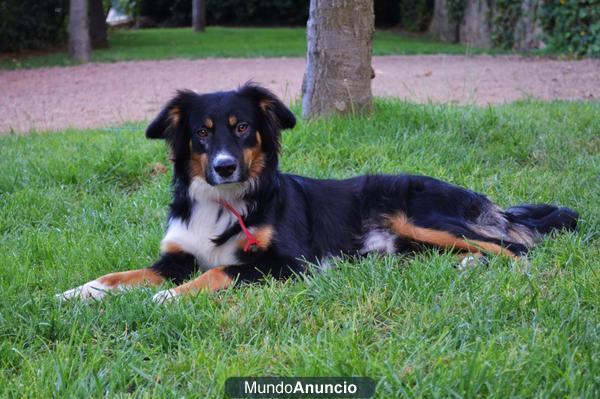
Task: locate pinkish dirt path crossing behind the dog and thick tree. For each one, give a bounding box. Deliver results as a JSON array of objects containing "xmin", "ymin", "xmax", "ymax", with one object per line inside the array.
[{"xmin": 0, "ymin": 55, "xmax": 600, "ymax": 132}]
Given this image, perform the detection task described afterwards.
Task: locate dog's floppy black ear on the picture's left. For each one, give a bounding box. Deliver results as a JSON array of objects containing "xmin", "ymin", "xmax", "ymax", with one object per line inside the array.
[{"xmin": 146, "ymin": 90, "xmax": 196, "ymax": 141}]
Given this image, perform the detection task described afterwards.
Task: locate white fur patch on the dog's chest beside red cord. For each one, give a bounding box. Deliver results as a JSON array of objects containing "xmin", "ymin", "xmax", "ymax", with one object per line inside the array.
[{"xmin": 162, "ymin": 179, "xmax": 247, "ymax": 269}]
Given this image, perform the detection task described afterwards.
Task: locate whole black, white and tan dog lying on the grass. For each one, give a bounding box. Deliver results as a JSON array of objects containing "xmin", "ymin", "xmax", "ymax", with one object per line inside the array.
[{"xmin": 59, "ymin": 84, "xmax": 578, "ymax": 302}]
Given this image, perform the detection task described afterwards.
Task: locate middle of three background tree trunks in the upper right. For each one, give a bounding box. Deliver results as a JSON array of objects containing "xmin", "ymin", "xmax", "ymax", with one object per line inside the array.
[{"xmin": 459, "ymin": 0, "xmax": 494, "ymax": 49}]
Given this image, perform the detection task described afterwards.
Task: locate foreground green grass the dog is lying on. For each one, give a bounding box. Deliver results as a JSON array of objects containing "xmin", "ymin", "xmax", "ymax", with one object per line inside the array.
[{"xmin": 0, "ymin": 100, "xmax": 600, "ymax": 398}]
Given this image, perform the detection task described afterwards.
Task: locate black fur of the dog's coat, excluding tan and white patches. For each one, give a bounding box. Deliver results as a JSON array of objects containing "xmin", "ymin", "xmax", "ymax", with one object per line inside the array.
[{"xmin": 146, "ymin": 85, "xmax": 578, "ymax": 290}]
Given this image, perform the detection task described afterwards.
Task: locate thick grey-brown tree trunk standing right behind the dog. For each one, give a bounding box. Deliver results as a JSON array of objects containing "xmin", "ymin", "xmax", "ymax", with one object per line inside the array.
[{"xmin": 302, "ymin": 0, "xmax": 375, "ymax": 118}]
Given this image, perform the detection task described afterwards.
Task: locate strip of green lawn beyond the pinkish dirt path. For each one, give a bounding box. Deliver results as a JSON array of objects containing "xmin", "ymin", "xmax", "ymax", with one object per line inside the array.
[{"xmin": 0, "ymin": 27, "xmax": 486, "ymax": 69}]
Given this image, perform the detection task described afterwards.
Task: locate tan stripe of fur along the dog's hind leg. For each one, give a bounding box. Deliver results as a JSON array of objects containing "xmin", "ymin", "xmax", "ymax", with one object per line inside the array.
[{"xmin": 389, "ymin": 213, "xmax": 518, "ymax": 258}]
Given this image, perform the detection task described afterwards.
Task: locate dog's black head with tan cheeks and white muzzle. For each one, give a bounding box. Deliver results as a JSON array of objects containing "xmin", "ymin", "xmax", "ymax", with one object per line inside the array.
[{"xmin": 146, "ymin": 84, "xmax": 296, "ymax": 186}]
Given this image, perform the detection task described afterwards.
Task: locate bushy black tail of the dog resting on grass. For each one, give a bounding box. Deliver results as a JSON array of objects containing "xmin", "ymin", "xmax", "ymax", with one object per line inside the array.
[{"xmin": 504, "ymin": 204, "xmax": 579, "ymax": 235}]
